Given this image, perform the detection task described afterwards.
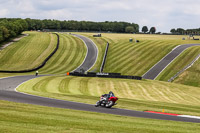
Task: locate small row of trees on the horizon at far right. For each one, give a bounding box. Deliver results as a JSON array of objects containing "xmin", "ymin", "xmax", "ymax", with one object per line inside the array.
[{"xmin": 170, "ymin": 28, "xmax": 200, "ymax": 35}]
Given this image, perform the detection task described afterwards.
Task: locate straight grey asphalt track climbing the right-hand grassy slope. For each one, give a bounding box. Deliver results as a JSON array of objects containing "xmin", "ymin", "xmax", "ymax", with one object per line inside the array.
[{"xmin": 142, "ymin": 44, "xmax": 200, "ymax": 80}]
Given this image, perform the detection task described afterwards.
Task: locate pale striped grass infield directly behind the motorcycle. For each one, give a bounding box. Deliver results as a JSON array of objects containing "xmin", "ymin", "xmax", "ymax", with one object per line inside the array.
[{"xmin": 17, "ymin": 76, "xmax": 200, "ymax": 116}]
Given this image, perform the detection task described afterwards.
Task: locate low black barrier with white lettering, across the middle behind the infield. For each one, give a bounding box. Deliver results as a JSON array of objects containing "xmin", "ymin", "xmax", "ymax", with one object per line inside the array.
[{"xmin": 69, "ymin": 72, "xmax": 142, "ymax": 80}]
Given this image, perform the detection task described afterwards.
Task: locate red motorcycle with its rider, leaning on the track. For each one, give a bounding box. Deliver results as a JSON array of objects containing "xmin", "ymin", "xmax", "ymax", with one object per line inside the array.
[{"xmin": 95, "ymin": 93, "xmax": 118, "ymax": 108}]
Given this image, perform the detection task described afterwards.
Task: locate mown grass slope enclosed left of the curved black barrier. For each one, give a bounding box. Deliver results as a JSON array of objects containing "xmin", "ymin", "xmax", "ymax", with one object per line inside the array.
[{"xmin": 0, "ymin": 32, "xmax": 57, "ymax": 70}]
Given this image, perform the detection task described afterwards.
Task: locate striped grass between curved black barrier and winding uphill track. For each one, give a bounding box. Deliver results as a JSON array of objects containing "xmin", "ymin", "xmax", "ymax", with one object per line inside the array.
[{"xmin": 39, "ymin": 34, "xmax": 87, "ymax": 74}]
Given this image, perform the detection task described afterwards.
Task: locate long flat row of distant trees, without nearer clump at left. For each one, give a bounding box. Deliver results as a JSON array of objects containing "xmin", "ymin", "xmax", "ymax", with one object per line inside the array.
[{"xmin": 25, "ymin": 18, "xmax": 139, "ymax": 33}]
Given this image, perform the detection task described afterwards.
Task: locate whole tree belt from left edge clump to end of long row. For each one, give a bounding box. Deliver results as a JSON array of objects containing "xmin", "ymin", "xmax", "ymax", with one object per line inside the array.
[{"xmin": 0, "ymin": 18, "xmax": 139, "ymax": 42}]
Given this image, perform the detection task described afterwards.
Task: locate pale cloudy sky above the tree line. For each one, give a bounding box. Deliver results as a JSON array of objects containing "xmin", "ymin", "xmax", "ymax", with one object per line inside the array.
[{"xmin": 0, "ymin": 0, "xmax": 200, "ymax": 32}]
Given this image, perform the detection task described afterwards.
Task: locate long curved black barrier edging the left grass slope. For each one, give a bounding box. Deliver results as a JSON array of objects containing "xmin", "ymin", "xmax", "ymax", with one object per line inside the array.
[{"xmin": 0, "ymin": 33, "xmax": 60, "ymax": 73}]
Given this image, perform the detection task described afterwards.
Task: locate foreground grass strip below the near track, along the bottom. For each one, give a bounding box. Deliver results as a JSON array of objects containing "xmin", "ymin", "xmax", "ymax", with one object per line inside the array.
[{"xmin": 0, "ymin": 101, "xmax": 200, "ymax": 133}]
